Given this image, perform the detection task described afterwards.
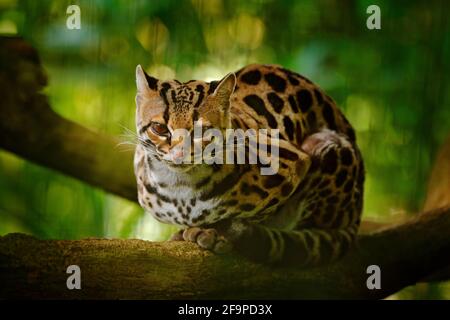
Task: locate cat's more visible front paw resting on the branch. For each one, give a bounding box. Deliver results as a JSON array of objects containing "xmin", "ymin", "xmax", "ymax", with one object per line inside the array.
[{"xmin": 182, "ymin": 227, "xmax": 232, "ymax": 254}]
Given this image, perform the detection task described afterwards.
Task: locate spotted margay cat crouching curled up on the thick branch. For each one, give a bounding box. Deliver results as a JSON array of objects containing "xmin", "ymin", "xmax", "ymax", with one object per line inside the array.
[{"xmin": 135, "ymin": 64, "xmax": 364, "ymax": 266}]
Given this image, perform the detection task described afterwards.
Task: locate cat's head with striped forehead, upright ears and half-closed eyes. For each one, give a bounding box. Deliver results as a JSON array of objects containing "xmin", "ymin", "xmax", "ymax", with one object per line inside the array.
[{"xmin": 136, "ymin": 65, "xmax": 236, "ymax": 171}]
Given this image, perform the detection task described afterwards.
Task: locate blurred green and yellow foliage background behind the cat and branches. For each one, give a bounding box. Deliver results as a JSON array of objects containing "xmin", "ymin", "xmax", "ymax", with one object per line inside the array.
[{"xmin": 0, "ymin": 0, "xmax": 450, "ymax": 298}]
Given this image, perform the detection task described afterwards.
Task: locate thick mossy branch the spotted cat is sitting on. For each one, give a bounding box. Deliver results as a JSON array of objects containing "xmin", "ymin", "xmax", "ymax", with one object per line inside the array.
[{"xmin": 0, "ymin": 208, "xmax": 450, "ymax": 299}]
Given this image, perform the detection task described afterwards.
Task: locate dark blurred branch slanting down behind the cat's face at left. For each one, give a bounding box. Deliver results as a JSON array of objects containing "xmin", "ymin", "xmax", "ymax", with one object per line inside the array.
[{"xmin": 0, "ymin": 37, "xmax": 137, "ymax": 201}]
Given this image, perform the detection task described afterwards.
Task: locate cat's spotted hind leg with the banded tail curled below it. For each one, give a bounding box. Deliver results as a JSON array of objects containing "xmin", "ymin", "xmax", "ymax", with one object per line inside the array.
[{"xmin": 227, "ymin": 130, "xmax": 364, "ymax": 266}]
